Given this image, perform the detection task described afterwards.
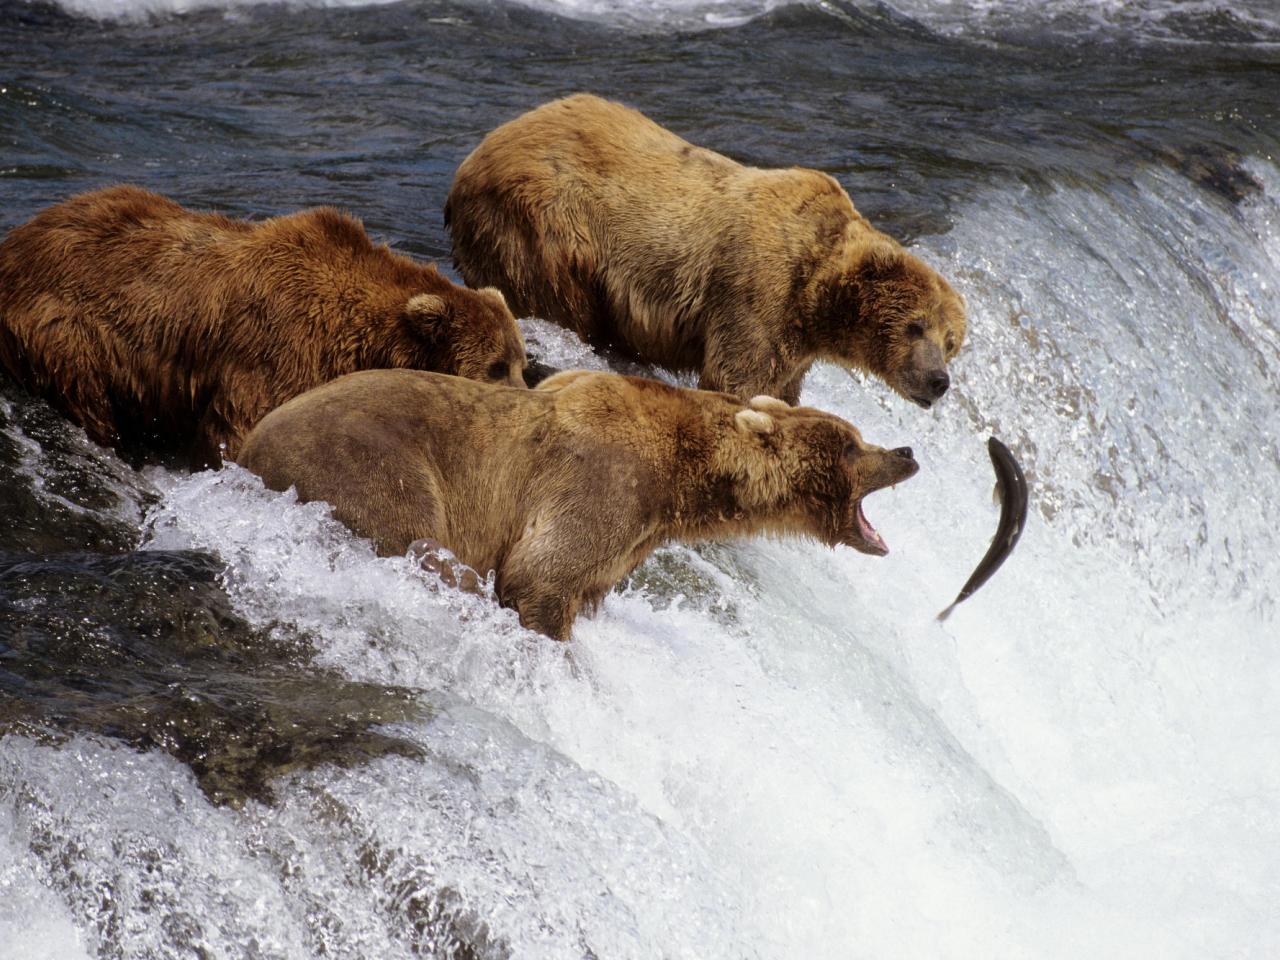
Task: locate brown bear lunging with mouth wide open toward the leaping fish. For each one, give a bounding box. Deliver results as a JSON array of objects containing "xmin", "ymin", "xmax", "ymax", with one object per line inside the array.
[{"xmin": 239, "ymin": 370, "xmax": 918, "ymax": 640}]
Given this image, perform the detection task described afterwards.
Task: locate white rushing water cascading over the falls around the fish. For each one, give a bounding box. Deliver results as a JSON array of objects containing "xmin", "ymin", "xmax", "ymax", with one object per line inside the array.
[{"xmin": 0, "ymin": 150, "xmax": 1280, "ymax": 960}]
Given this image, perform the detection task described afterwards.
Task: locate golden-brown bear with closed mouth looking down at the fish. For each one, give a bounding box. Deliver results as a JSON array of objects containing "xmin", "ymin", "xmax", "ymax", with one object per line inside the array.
[{"xmin": 444, "ymin": 93, "xmax": 965, "ymax": 407}]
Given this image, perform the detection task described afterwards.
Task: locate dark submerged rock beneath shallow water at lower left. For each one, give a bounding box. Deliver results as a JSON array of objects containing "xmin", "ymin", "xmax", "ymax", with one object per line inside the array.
[{"xmin": 0, "ymin": 550, "xmax": 426, "ymax": 806}]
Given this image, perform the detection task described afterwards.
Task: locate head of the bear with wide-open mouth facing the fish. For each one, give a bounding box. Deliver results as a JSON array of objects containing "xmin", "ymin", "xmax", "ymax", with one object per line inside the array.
[{"xmin": 735, "ymin": 397, "xmax": 920, "ymax": 557}]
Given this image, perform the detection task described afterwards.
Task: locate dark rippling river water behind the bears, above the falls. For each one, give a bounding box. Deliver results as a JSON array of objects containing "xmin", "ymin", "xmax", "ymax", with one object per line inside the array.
[{"xmin": 0, "ymin": 3, "xmax": 1280, "ymax": 249}]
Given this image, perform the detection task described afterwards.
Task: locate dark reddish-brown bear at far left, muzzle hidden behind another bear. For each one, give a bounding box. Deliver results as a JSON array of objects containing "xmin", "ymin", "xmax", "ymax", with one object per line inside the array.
[{"xmin": 0, "ymin": 186, "xmax": 525, "ymax": 466}]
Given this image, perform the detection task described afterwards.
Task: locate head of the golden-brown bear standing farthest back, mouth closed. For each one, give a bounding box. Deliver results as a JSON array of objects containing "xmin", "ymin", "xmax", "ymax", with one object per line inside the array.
[{"xmin": 815, "ymin": 238, "xmax": 966, "ymax": 408}]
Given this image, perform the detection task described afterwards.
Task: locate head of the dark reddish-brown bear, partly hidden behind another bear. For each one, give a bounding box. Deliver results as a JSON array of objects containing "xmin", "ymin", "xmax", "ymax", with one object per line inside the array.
[{"xmin": 404, "ymin": 287, "xmax": 526, "ymax": 388}]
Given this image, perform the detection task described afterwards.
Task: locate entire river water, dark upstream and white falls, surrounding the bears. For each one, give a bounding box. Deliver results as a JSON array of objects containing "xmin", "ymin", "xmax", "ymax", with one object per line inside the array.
[{"xmin": 0, "ymin": 0, "xmax": 1280, "ymax": 960}]
